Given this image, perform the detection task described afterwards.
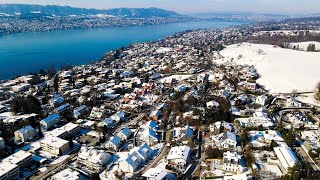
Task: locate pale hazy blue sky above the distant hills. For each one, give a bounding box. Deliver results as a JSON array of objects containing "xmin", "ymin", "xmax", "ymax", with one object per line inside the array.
[{"xmin": 0, "ymin": 0, "xmax": 320, "ymax": 14}]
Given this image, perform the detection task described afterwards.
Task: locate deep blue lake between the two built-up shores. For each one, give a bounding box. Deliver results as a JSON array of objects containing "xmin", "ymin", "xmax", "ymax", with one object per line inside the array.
[{"xmin": 0, "ymin": 20, "xmax": 244, "ymax": 80}]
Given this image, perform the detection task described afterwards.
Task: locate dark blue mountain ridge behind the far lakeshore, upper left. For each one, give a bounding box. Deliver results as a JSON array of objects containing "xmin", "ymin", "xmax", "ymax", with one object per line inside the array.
[{"xmin": 0, "ymin": 4, "xmax": 182, "ymax": 18}]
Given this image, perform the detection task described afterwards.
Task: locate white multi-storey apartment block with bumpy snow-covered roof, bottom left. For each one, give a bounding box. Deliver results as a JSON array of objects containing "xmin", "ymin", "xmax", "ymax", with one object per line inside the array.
[{"xmin": 77, "ymin": 146, "xmax": 111, "ymax": 172}]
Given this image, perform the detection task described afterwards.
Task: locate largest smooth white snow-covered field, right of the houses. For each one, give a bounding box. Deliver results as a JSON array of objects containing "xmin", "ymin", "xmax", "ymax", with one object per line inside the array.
[{"xmin": 217, "ymin": 43, "xmax": 320, "ymax": 93}]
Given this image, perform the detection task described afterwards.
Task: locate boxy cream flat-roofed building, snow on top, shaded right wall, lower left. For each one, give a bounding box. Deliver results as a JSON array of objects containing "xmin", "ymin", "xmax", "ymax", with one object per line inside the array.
[{"xmin": 40, "ymin": 136, "xmax": 70, "ymax": 156}]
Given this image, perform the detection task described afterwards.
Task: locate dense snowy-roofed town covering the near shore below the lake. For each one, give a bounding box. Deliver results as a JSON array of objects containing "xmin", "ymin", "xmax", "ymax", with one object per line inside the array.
[{"xmin": 0, "ymin": 25, "xmax": 320, "ymax": 180}]
